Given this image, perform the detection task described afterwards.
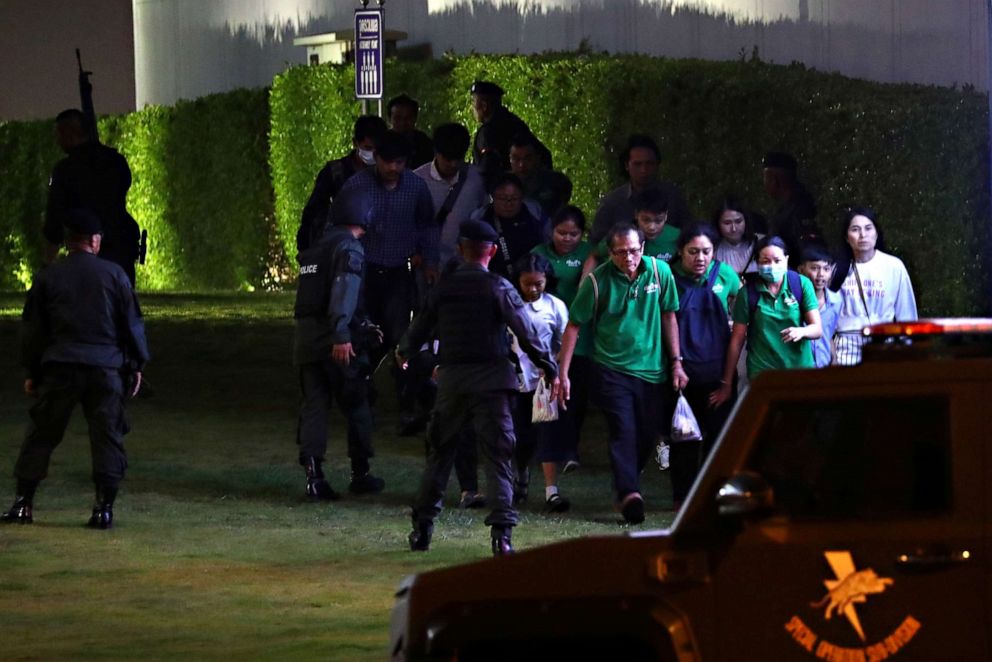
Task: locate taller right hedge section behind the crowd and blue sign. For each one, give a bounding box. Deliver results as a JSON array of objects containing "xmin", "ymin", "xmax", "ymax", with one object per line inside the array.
[{"xmin": 270, "ymin": 54, "xmax": 989, "ymax": 315}]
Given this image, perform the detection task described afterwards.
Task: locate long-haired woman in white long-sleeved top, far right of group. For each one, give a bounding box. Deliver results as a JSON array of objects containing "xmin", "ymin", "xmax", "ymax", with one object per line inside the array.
[{"xmin": 830, "ymin": 207, "xmax": 917, "ymax": 365}]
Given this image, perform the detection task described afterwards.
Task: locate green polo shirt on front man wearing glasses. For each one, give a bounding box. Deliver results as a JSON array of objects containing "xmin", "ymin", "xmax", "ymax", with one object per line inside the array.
[{"xmin": 568, "ymin": 257, "xmax": 679, "ymax": 384}]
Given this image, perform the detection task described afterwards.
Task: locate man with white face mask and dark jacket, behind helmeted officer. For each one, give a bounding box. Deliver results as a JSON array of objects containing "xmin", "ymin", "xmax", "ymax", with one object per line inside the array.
[{"xmin": 296, "ymin": 115, "xmax": 386, "ymax": 252}]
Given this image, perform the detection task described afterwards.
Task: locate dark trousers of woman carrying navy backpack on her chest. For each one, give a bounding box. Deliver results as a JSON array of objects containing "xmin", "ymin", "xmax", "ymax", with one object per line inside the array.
[{"xmin": 663, "ymin": 378, "xmax": 737, "ymax": 502}]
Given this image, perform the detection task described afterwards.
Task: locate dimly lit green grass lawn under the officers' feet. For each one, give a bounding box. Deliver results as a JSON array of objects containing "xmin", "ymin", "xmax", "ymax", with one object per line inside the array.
[{"xmin": 0, "ymin": 293, "xmax": 671, "ymax": 660}]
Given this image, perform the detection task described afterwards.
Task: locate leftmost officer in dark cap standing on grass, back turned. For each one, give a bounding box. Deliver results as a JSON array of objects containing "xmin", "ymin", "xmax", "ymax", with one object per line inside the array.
[{"xmin": 0, "ymin": 210, "xmax": 148, "ymax": 529}]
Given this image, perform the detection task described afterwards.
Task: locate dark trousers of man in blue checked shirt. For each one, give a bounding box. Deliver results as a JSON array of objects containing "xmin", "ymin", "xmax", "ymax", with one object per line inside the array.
[{"xmin": 364, "ymin": 264, "xmax": 419, "ymax": 412}]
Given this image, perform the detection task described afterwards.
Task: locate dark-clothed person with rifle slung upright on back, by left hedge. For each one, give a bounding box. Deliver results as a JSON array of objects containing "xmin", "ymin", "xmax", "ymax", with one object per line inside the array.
[{"xmin": 43, "ymin": 108, "xmax": 140, "ymax": 286}]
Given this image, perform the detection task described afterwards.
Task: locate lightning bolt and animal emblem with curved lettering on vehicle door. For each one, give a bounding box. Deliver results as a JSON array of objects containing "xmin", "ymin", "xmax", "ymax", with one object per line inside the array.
[{"xmin": 785, "ymin": 551, "xmax": 921, "ymax": 660}]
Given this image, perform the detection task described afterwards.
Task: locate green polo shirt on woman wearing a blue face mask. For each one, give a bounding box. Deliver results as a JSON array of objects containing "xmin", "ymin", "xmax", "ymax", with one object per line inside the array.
[{"xmin": 734, "ymin": 276, "xmax": 818, "ymax": 377}]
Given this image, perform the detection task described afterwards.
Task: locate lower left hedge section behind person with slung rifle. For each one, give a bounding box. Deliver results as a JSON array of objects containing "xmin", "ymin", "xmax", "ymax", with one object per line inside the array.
[{"xmin": 0, "ymin": 90, "xmax": 276, "ymax": 290}]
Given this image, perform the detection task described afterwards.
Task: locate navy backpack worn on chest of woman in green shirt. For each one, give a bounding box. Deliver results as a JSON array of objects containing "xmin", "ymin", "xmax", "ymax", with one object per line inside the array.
[{"xmin": 674, "ymin": 260, "xmax": 730, "ymax": 383}]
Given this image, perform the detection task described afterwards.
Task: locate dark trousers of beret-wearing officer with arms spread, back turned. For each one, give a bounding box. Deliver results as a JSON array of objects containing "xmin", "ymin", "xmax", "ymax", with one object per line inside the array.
[{"xmin": 413, "ymin": 390, "xmax": 518, "ymax": 530}]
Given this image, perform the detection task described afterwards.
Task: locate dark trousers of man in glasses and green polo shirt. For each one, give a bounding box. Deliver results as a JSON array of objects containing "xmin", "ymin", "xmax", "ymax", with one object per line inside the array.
[{"xmin": 592, "ymin": 363, "xmax": 668, "ymax": 500}]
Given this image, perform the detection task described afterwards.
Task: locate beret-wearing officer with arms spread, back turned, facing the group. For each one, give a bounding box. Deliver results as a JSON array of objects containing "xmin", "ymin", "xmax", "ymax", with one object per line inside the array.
[{"xmin": 396, "ymin": 221, "xmax": 558, "ymax": 556}]
